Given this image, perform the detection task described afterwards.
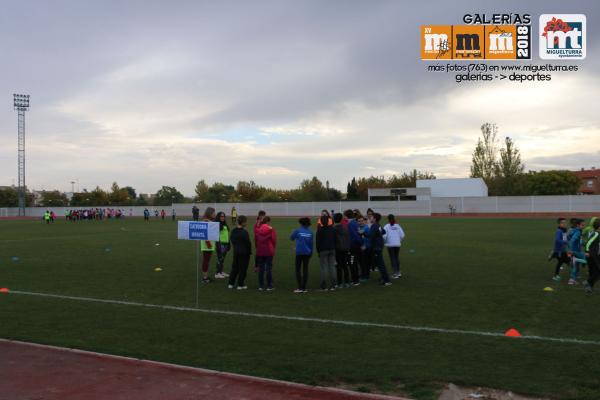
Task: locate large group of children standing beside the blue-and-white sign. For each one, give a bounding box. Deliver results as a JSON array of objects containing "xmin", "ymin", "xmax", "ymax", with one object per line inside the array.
[{"xmin": 200, "ymin": 207, "xmax": 405, "ymax": 293}]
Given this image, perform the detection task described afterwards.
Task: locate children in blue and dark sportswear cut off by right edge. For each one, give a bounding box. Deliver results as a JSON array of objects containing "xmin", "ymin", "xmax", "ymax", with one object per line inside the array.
[{"xmin": 548, "ymin": 217, "xmax": 600, "ymax": 293}]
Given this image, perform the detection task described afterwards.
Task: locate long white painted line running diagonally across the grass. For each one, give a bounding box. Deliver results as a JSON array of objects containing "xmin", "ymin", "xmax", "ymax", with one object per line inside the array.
[{"xmin": 8, "ymin": 290, "xmax": 600, "ymax": 346}]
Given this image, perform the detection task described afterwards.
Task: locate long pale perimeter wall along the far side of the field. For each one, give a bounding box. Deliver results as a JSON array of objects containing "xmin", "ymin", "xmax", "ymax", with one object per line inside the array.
[{"xmin": 0, "ymin": 196, "xmax": 600, "ymax": 217}]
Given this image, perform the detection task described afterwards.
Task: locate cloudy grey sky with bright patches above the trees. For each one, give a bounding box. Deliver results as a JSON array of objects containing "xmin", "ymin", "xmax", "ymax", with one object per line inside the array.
[{"xmin": 0, "ymin": 0, "xmax": 600, "ymax": 195}]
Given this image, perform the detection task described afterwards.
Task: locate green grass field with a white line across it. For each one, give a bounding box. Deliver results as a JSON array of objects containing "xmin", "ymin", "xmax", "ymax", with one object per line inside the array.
[{"xmin": 0, "ymin": 218, "xmax": 600, "ymax": 399}]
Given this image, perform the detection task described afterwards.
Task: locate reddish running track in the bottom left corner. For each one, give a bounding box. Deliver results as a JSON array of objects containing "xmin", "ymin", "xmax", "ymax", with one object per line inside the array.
[{"xmin": 0, "ymin": 339, "xmax": 408, "ymax": 400}]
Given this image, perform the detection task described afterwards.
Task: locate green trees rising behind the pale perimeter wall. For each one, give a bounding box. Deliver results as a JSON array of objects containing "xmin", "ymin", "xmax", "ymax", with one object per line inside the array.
[{"xmin": 0, "ymin": 123, "xmax": 581, "ymax": 207}]
